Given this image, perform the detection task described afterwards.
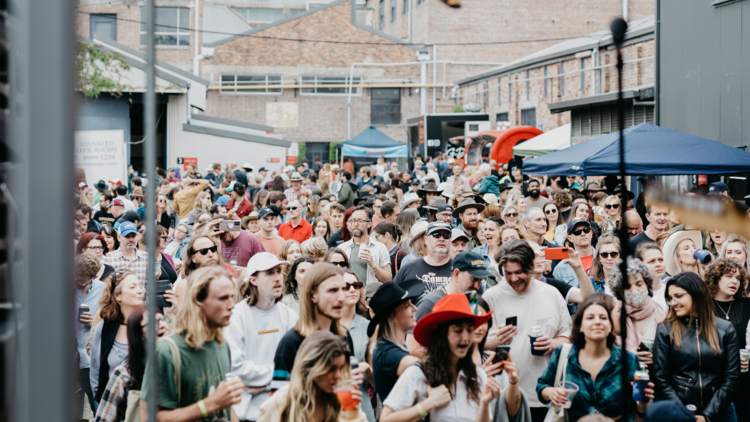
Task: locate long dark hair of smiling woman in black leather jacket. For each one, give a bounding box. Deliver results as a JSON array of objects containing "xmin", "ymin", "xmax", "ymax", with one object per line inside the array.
[{"xmin": 664, "ymin": 271, "xmax": 721, "ymax": 355}]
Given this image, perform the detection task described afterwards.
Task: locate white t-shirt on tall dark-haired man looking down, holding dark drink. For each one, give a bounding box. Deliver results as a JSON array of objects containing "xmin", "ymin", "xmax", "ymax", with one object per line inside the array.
[{"xmin": 482, "ymin": 280, "xmax": 572, "ymax": 407}]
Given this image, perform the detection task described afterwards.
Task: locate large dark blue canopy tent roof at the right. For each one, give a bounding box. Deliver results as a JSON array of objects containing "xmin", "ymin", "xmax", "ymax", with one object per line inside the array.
[{"xmin": 523, "ymin": 123, "xmax": 750, "ymax": 176}]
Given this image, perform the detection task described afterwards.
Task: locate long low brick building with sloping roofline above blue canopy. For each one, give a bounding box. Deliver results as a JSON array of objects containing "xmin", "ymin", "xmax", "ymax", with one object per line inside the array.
[{"xmin": 454, "ymin": 16, "xmax": 655, "ymax": 143}]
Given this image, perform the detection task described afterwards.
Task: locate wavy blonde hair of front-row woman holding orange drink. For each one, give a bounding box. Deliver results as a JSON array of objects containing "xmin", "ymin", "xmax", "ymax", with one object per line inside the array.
[{"xmin": 280, "ymin": 331, "xmax": 350, "ymax": 422}]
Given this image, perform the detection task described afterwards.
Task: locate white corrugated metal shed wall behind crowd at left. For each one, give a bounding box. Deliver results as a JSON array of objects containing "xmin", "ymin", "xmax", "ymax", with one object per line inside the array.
[{"xmin": 167, "ymin": 95, "xmax": 286, "ymax": 172}]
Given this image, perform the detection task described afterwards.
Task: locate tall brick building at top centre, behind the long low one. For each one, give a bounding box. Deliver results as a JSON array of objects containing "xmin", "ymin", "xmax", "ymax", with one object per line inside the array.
[{"xmin": 364, "ymin": 0, "xmax": 654, "ymax": 112}]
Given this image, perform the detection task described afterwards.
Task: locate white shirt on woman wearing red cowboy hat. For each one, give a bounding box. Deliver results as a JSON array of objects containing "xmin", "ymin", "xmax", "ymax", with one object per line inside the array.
[{"xmin": 383, "ymin": 365, "xmax": 497, "ymax": 422}]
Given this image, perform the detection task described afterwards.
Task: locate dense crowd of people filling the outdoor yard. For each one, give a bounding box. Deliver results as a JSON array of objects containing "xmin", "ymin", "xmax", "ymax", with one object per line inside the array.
[{"xmin": 75, "ymin": 155, "xmax": 750, "ymax": 422}]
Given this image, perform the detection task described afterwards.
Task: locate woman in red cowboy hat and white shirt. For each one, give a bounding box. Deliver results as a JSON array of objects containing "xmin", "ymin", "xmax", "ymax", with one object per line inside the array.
[{"xmin": 380, "ymin": 293, "xmax": 528, "ymax": 422}]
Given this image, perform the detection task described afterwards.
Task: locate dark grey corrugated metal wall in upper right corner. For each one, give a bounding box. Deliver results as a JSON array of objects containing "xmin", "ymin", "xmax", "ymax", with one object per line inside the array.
[{"xmin": 659, "ymin": 0, "xmax": 750, "ymax": 150}]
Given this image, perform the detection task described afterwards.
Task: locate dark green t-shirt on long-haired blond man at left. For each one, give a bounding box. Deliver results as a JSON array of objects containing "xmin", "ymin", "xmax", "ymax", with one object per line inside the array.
[{"xmin": 141, "ymin": 334, "xmax": 232, "ymax": 421}]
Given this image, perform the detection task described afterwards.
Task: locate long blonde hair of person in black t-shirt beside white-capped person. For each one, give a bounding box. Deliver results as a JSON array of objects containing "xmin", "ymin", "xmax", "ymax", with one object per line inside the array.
[{"xmin": 294, "ymin": 262, "xmax": 346, "ymax": 337}]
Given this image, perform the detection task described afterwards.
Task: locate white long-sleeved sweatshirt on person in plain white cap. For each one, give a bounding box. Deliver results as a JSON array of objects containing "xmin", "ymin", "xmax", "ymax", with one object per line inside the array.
[{"xmin": 224, "ymin": 301, "xmax": 299, "ymax": 421}]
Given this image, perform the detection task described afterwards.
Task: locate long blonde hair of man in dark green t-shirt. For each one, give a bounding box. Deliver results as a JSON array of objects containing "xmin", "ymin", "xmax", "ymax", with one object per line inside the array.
[{"xmin": 174, "ymin": 265, "xmax": 232, "ymax": 349}]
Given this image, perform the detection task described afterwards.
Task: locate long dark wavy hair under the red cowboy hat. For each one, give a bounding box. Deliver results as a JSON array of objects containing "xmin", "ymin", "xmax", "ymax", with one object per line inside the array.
[{"xmin": 422, "ymin": 319, "xmax": 481, "ymax": 403}]
